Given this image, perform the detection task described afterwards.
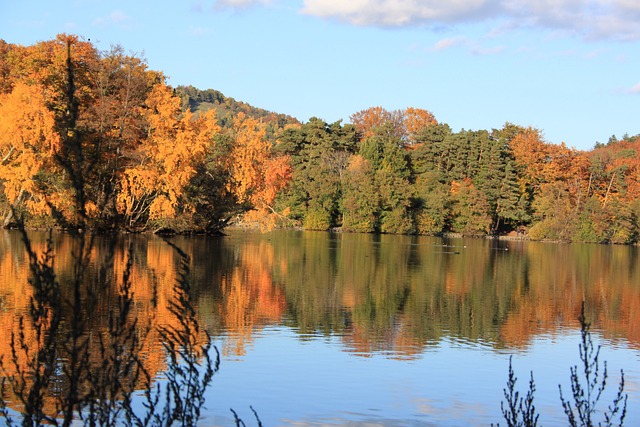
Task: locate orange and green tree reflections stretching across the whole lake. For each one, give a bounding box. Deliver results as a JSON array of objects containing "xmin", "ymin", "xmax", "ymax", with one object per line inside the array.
[{"xmin": 0, "ymin": 230, "xmax": 640, "ymax": 421}]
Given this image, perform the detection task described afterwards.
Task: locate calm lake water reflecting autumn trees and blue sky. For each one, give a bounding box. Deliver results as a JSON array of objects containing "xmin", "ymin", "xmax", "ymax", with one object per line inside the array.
[{"xmin": 0, "ymin": 230, "xmax": 640, "ymax": 426}]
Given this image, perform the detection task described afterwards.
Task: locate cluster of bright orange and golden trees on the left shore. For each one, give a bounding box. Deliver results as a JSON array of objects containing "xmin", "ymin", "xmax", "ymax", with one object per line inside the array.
[{"xmin": 0, "ymin": 35, "xmax": 286, "ymax": 233}]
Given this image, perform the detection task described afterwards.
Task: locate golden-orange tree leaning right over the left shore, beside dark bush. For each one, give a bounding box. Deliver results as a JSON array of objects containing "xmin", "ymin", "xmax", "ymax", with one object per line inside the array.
[{"xmin": 117, "ymin": 83, "xmax": 220, "ymax": 228}]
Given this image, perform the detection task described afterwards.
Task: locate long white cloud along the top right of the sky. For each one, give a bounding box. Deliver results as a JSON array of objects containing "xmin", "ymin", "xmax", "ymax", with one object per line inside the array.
[{"xmin": 300, "ymin": 0, "xmax": 640, "ymax": 40}]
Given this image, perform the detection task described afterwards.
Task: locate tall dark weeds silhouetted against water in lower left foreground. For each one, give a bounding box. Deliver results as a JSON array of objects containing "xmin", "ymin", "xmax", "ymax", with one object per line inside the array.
[{"xmin": 0, "ymin": 230, "xmax": 220, "ymax": 426}]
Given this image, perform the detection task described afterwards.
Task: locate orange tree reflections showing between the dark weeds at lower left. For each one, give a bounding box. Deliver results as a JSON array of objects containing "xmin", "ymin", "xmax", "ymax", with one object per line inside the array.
[{"xmin": 0, "ymin": 232, "xmax": 206, "ymax": 414}]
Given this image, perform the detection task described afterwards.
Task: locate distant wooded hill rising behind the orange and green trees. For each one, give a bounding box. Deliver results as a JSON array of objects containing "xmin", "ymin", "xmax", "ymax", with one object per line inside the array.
[{"xmin": 175, "ymin": 86, "xmax": 300, "ymax": 131}]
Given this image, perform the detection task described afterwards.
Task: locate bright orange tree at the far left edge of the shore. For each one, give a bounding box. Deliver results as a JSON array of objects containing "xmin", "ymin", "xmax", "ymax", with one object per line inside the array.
[{"xmin": 0, "ymin": 34, "xmax": 98, "ymax": 225}]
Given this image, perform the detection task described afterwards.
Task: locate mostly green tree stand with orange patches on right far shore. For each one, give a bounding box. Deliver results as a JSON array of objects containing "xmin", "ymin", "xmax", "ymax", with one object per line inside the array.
[{"xmin": 274, "ymin": 115, "xmax": 640, "ymax": 243}]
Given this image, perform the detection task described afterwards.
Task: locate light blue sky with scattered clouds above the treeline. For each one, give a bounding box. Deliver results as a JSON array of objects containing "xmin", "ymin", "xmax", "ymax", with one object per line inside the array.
[{"xmin": 0, "ymin": 0, "xmax": 640, "ymax": 150}]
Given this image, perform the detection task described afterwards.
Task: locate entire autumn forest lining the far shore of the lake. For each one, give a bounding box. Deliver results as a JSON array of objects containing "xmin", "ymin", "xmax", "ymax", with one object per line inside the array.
[{"xmin": 0, "ymin": 34, "xmax": 640, "ymax": 244}]
